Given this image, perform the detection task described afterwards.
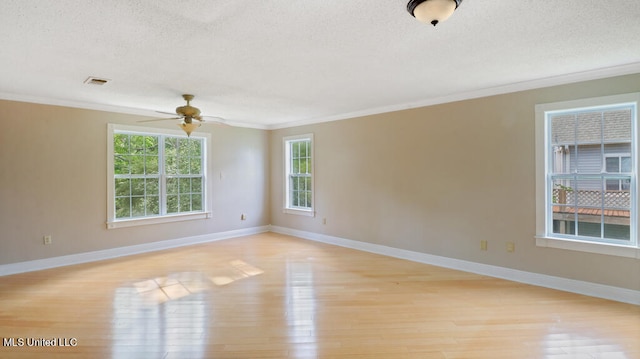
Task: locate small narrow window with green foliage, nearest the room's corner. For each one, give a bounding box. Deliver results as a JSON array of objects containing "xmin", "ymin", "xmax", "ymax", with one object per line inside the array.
[{"xmin": 284, "ymin": 134, "xmax": 314, "ymax": 216}]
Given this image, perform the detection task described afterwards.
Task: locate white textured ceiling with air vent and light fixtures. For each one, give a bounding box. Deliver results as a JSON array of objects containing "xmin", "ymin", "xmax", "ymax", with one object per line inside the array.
[{"xmin": 0, "ymin": 0, "xmax": 640, "ymax": 128}]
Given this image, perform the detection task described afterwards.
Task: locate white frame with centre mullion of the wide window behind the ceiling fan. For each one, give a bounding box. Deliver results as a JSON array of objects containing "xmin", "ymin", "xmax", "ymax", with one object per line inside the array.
[{"xmin": 106, "ymin": 123, "xmax": 211, "ymax": 229}]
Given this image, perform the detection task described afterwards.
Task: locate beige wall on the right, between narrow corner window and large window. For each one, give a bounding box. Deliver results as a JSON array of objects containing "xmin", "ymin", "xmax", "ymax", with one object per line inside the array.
[{"xmin": 271, "ymin": 75, "xmax": 640, "ymax": 290}]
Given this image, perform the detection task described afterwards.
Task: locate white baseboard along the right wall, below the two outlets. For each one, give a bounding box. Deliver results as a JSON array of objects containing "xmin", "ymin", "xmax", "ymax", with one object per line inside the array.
[{"xmin": 270, "ymin": 226, "xmax": 640, "ymax": 305}]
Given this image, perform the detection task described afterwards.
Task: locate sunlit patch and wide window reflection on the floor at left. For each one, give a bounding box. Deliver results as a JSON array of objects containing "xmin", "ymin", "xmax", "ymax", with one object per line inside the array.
[{"xmin": 112, "ymin": 260, "xmax": 264, "ymax": 359}]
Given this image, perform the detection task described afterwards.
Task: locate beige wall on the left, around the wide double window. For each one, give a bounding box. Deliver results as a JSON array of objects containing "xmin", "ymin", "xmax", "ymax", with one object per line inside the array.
[{"xmin": 0, "ymin": 101, "xmax": 269, "ymax": 264}]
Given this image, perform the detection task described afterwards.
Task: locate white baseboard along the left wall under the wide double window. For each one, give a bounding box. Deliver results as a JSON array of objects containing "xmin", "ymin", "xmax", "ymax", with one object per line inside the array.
[{"xmin": 0, "ymin": 226, "xmax": 269, "ymax": 276}]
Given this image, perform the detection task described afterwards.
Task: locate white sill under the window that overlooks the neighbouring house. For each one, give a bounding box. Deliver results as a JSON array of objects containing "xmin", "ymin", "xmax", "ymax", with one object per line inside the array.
[{"xmin": 536, "ymin": 236, "xmax": 640, "ymax": 259}]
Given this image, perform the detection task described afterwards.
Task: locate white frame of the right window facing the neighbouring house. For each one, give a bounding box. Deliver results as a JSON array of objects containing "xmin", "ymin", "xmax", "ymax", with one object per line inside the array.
[{"xmin": 535, "ymin": 93, "xmax": 640, "ymax": 258}]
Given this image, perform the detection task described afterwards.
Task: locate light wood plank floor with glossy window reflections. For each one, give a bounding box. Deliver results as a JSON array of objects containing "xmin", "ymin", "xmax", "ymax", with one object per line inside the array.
[{"xmin": 0, "ymin": 233, "xmax": 640, "ymax": 359}]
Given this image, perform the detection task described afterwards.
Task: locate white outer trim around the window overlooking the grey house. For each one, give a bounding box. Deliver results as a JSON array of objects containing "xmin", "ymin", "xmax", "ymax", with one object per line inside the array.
[{"xmin": 535, "ymin": 93, "xmax": 640, "ymax": 259}]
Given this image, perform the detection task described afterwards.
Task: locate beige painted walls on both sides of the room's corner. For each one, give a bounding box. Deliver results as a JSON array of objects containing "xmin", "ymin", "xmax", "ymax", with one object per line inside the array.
[{"xmin": 0, "ymin": 74, "xmax": 640, "ymax": 290}]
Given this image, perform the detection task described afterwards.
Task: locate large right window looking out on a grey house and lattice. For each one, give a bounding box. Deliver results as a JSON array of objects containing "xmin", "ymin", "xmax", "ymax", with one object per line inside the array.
[{"xmin": 536, "ymin": 94, "xmax": 640, "ymax": 256}]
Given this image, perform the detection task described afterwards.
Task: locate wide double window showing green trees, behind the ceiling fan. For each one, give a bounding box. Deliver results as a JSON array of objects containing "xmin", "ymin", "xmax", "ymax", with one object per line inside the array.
[{"xmin": 107, "ymin": 125, "xmax": 209, "ymax": 228}]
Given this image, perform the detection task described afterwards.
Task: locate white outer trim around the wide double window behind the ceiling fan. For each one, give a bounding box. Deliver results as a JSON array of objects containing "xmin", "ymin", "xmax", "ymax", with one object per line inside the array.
[{"xmin": 106, "ymin": 123, "xmax": 212, "ymax": 229}]
